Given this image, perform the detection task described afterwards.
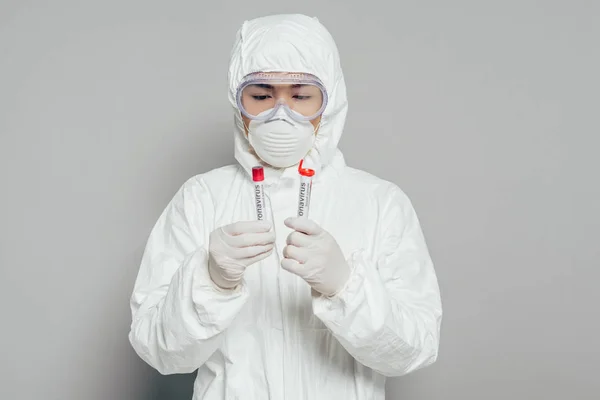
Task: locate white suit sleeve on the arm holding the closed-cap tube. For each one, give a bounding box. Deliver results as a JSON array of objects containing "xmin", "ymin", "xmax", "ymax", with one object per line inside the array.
[{"xmin": 129, "ymin": 176, "xmax": 248, "ymax": 375}]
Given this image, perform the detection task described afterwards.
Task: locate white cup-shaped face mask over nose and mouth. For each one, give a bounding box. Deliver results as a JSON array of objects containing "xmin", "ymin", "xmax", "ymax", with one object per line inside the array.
[{"xmin": 248, "ymin": 109, "xmax": 315, "ymax": 168}]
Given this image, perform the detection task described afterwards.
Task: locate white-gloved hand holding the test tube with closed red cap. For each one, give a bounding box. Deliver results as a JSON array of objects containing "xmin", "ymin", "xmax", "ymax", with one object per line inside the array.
[{"xmin": 208, "ymin": 221, "xmax": 275, "ymax": 289}]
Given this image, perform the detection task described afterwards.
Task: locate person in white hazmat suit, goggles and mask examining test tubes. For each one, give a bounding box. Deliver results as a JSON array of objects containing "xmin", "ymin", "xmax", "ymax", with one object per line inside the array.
[{"xmin": 129, "ymin": 14, "xmax": 442, "ymax": 400}]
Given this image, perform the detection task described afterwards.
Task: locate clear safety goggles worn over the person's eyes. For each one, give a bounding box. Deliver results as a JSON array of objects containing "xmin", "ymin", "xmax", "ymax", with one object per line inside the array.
[{"xmin": 237, "ymin": 72, "xmax": 327, "ymax": 121}]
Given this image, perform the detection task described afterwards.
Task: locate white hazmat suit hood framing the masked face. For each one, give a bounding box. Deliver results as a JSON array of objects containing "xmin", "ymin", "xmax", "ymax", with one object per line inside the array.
[{"xmin": 228, "ymin": 14, "xmax": 348, "ymax": 184}]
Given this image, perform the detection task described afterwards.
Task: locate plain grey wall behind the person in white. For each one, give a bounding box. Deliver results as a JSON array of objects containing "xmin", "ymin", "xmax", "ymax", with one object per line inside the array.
[{"xmin": 0, "ymin": 0, "xmax": 600, "ymax": 400}]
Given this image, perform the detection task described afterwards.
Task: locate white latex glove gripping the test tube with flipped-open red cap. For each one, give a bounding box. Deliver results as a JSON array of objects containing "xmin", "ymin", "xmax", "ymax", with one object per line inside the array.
[{"xmin": 281, "ymin": 218, "xmax": 350, "ymax": 296}]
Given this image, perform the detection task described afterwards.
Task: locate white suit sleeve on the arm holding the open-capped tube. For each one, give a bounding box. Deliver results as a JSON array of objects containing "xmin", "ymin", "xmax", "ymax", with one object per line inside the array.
[{"xmin": 313, "ymin": 186, "xmax": 442, "ymax": 377}]
